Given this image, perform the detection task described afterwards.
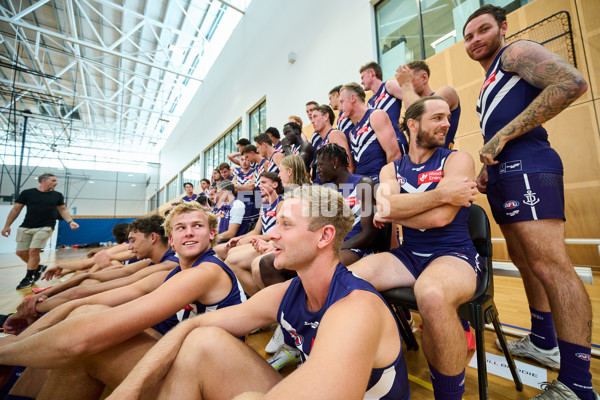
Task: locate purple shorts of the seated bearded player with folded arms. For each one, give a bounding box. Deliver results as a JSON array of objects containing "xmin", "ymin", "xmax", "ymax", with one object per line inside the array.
[{"xmin": 390, "ymin": 246, "xmax": 483, "ymax": 285}]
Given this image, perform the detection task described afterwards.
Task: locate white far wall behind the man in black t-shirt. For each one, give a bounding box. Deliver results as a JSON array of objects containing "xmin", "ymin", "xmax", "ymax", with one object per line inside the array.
[{"xmin": 0, "ymin": 166, "xmax": 149, "ymax": 216}]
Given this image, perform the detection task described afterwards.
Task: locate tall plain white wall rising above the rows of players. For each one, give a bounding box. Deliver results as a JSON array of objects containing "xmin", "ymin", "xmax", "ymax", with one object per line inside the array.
[{"xmin": 160, "ymin": 0, "xmax": 375, "ymax": 186}]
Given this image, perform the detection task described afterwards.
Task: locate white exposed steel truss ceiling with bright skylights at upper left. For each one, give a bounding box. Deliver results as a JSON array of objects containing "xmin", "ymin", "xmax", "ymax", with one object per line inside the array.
[{"xmin": 0, "ymin": 0, "xmax": 250, "ymax": 172}]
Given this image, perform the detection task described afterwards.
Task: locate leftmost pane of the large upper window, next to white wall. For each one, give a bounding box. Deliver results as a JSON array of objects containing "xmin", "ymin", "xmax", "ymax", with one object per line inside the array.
[{"xmin": 375, "ymin": 0, "xmax": 422, "ymax": 80}]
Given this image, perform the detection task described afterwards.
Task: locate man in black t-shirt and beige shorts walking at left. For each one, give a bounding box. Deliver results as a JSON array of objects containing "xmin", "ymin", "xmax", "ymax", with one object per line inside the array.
[{"xmin": 2, "ymin": 174, "xmax": 79, "ymax": 289}]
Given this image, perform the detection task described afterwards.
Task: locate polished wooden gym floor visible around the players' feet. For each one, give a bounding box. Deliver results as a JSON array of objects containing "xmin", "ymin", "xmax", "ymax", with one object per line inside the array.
[{"xmin": 0, "ymin": 249, "xmax": 600, "ymax": 400}]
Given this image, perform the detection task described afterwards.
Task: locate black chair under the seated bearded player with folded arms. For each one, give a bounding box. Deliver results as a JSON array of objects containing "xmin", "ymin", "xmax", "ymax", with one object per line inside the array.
[{"xmin": 381, "ymin": 204, "xmax": 523, "ymax": 400}]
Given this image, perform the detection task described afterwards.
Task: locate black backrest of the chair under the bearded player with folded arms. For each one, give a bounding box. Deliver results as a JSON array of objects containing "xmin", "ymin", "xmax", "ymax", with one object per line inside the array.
[{"xmin": 467, "ymin": 204, "xmax": 494, "ymax": 298}]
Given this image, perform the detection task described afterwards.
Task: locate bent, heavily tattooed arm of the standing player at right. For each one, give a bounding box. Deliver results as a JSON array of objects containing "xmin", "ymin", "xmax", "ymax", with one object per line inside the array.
[{"xmin": 479, "ymin": 41, "xmax": 587, "ymax": 165}]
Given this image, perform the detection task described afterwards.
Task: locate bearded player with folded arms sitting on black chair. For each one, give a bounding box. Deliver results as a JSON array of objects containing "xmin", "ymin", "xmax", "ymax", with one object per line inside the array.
[{"xmin": 349, "ymin": 96, "xmax": 481, "ymax": 400}]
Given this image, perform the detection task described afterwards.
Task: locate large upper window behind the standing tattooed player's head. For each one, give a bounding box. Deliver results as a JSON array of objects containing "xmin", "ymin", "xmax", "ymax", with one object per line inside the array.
[{"xmin": 375, "ymin": 0, "xmax": 532, "ymax": 80}]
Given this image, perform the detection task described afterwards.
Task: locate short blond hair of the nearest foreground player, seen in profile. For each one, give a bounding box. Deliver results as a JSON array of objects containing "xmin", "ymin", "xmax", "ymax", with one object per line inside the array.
[{"xmin": 284, "ymin": 185, "xmax": 354, "ymax": 254}]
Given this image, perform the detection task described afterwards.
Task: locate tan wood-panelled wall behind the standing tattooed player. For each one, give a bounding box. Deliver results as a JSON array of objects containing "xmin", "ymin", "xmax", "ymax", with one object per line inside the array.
[{"xmin": 427, "ymin": 0, "xmax": 600, "ymax": 267}]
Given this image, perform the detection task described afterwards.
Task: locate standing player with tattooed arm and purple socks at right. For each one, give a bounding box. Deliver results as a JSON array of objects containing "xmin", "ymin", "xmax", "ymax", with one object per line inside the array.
[{"xmin": 463, "ymin": 5, "xmax": 599, "ymax": 400}]
